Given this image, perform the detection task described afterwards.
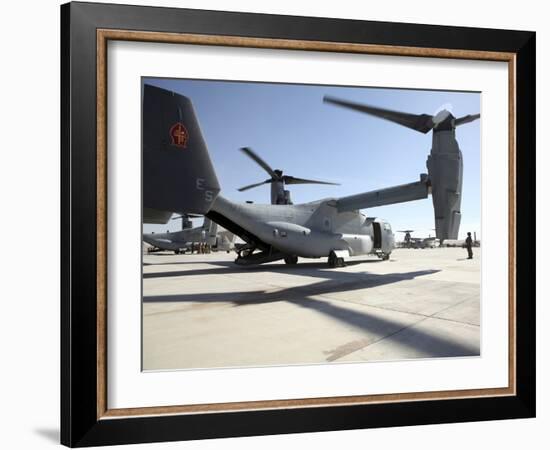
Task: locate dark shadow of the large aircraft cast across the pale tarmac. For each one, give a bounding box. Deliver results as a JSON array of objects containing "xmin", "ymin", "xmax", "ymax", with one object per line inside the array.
[{"xmin": 143, "ymin": 263, "xmax": 479, "ymax": 360}]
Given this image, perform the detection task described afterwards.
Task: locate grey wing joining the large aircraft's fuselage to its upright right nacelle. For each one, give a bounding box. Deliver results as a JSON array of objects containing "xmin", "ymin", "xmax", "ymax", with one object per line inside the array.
[{"xmin": 329, "ymin": 174, "xmax": 429, "ymax": 212}]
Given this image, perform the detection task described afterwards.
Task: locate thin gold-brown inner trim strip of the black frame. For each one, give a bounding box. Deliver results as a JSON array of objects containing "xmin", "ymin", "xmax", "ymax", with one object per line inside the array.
[{"xmin": 96, "ymin": 29, "xmax": 516, "ymax": 420}]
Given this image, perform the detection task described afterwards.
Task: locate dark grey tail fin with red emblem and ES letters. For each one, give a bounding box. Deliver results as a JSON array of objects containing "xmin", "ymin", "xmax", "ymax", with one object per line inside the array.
[{"xmin": 142, "ymin": 84, "xmax": 220, "ymax": 221}]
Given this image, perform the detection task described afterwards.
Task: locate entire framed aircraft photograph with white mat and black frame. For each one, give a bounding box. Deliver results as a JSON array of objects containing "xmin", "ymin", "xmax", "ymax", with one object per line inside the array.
[{"xmin": 61, "ymin": 3, "xmax": 535, "ymax": 447}]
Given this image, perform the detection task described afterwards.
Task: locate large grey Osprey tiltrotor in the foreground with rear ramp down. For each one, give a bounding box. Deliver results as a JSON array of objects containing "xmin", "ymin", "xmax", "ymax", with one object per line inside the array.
[{"xmin": 142, "ymin": 85, "xmax": 479, "ymax": 267}]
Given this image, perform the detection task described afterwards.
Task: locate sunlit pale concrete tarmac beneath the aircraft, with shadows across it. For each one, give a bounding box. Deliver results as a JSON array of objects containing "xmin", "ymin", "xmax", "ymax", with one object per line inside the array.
[{"xmin": 143, "ymin": 248, "xmax": 481, "ymax": 370}]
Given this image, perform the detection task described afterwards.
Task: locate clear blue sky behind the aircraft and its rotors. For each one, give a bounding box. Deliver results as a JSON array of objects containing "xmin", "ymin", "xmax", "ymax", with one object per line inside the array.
[{"xmin": 143, "ymin": 78, "xmax": 481, "ymax": 240}]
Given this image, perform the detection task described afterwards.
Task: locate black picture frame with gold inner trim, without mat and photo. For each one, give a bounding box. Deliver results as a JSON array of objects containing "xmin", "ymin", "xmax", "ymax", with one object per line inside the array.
[{"xmin": 61, "ymin": 3, "xmax": 536, "ymax": 447}]
